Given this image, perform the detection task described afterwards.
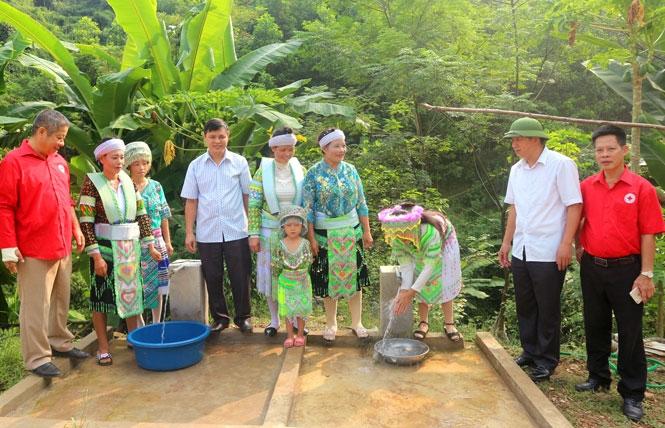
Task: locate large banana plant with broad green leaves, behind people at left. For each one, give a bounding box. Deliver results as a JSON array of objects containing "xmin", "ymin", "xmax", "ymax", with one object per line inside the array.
[{"xmin": 0, "ymin": 0, "xmax": 354, "ymax": 167}]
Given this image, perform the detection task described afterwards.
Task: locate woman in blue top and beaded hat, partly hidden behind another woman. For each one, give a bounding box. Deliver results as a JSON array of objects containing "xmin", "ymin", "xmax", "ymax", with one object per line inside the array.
[{"xmin": 125, "ymin": 141, "xmax": 173, "ymax": 324}]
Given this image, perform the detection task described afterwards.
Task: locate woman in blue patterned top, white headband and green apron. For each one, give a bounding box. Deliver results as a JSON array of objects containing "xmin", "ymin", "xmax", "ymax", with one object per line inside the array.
[{"xmin": 303, "ymin": 128, "xmax": 373, "ymax": 343}]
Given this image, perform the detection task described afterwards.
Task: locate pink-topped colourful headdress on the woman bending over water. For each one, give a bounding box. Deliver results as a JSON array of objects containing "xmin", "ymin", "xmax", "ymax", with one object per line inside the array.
[{"xmin": 379, "ymin": 204, "xmax": 424, "ymax": 248}]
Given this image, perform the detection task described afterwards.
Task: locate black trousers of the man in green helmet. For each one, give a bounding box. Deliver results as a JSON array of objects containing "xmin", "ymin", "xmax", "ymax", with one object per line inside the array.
[{"xmin": 511, "ymin": 256, "xmax": 566, "ymax": 370}]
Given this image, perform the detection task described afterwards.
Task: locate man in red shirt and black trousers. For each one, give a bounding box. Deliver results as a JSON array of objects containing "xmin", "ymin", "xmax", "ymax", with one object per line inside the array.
[{"xmin": 575, "ymin": 125, "xmax": 665, "ymax": 421}]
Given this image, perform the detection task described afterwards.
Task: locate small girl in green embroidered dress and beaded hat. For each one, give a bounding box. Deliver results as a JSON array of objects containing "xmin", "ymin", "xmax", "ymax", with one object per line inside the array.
[{"xmin": 271, "ymin": 206, "xmax": 312, "ymax": 348}]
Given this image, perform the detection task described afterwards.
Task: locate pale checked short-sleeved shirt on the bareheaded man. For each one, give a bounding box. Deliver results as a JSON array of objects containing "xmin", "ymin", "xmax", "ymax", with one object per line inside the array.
[{"xmin": 180, "ymin": 149, "xmax": 251, "ymax": 242}]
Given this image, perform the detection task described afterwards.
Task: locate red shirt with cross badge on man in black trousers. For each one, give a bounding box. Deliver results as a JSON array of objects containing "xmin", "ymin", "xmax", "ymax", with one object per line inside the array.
[{"xmin": 580, "ymin": 167, "xmax": 665, "ymax": 258}]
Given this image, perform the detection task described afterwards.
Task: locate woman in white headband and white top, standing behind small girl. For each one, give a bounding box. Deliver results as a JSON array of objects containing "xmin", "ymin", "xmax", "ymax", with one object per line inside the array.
[{"xmin": 249, "ymin": 128, "xmax": 305, "ymax": 336}]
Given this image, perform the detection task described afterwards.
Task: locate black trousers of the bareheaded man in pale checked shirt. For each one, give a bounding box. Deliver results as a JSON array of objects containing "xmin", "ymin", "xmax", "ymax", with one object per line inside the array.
[{"xmin": 196, "ymin": 238, "xmax": 252, "ymax": 325}]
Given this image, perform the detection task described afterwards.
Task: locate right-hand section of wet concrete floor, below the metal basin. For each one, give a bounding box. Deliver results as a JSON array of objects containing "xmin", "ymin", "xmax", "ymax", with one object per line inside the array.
[{"xmin": 288, "ymin": 345, "xmax": 536, "ymax": 428}]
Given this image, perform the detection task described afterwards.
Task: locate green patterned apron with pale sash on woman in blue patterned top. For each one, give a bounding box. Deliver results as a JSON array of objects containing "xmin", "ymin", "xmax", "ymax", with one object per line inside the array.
[{"xmin": 315, "ymin": 210, "xmax": 359, "ymax": 299}]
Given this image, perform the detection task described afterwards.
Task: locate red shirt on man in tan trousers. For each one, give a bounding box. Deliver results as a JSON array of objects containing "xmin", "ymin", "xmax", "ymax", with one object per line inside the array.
[{"xmin": 0, "ymin": 140, "xmax": 73, "ymax": 260}]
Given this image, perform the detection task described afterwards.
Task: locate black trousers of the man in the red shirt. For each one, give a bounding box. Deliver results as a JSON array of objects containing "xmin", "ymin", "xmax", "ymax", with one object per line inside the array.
[{"xmin": 580, "ymin": 253, "xmax": 647, "ymax": 400}]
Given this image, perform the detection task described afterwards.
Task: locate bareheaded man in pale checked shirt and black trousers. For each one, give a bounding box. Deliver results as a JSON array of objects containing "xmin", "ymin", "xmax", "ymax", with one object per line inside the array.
[{"xmin": 180, "ymin": 119, "xmax": 252, "ymax": 332}]
